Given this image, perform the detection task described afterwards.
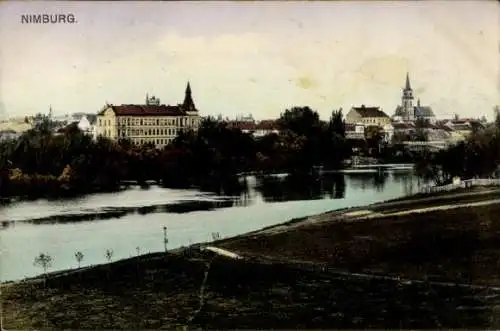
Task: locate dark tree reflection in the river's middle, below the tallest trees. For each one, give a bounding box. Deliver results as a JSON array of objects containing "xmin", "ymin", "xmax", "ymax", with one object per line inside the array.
[{"xmin": 255, "ymin": 173, "xmax": 346, "ymax": 202}]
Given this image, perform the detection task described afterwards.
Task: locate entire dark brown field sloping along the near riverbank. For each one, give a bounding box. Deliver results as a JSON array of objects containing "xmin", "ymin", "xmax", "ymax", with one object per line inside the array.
[{"xmin": 2, "ymin": 189, "xmax": 500, "ymax": 330}]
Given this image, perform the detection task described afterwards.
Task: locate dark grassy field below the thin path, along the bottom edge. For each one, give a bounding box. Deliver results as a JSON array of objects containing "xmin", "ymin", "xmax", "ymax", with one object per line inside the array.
[{"xmin": 3, "ymin": 249, "xmax": 498, "ymax": 330}]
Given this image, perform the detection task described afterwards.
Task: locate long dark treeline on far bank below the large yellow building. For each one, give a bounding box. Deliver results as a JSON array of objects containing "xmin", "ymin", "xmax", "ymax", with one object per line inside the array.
[{"xmin": 0, "ymin": 107, "xmax": 350, "ymax": 197}]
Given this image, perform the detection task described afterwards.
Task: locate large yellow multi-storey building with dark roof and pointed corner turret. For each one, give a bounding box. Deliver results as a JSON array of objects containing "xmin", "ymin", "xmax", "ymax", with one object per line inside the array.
[{"xmin": 96, "ymin": 82, "xmax": 201, "ymax": 148}]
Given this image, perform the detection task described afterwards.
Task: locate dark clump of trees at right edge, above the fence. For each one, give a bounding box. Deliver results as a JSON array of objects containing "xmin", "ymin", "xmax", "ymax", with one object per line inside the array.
[{"xmin": 416, "ymin": 110, "xmax": 500, "ymax": 185}]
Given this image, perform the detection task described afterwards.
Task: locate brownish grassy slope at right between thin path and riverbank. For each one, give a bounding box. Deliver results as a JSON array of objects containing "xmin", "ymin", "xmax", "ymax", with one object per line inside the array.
[{"xmin": 223, "ymin": 195, "xmax": 500, "ymax": 286}]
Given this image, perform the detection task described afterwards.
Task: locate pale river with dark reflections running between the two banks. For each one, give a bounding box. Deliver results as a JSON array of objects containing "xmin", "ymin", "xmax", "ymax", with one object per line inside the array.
[{"xmin": 0, "ymin": 166, "xmax": 423, "ymax": 281}]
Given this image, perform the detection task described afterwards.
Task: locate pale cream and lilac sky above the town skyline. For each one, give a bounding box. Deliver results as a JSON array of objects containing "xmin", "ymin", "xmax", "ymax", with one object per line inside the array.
[{"xmin": 0, "ymin": 1, "xmax": 500, "ymax": 119}]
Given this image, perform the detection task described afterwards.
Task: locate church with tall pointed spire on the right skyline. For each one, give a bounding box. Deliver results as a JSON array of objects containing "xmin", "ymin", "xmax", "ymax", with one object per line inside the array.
[{"xmin": 392, "ymin": 73, "xmax": 436, "ymax": 123}]
